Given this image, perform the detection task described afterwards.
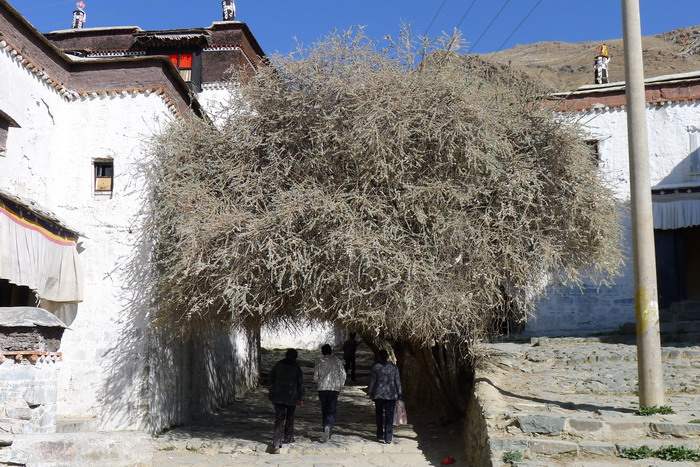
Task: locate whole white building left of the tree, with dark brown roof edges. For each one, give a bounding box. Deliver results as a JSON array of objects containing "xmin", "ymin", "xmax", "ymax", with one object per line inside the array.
[{"xmin": 0, "ymin": 0, "xmax": 263, "ymax": 433}]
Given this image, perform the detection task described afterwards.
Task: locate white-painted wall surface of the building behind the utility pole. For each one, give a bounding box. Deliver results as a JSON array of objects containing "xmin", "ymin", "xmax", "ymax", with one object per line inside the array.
[{"xmin": 519, "ymin": 82, "xmax": 700, "ymax": 337}]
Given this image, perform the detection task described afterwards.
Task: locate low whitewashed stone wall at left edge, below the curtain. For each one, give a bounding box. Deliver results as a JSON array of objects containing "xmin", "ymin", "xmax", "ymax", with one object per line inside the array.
[{"xmin": 0, "ymin": 352, "xmax": 61, "ymax": 437}]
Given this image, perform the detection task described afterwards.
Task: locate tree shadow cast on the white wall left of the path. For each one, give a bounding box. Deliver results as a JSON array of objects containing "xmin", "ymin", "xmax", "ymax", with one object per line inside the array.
[{"xmin": 98, "ymin": 149, "xmax": 259, "ymax": 433}]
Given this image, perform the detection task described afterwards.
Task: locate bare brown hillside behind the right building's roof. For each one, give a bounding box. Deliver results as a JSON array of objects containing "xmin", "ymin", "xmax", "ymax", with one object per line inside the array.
[{"xmin": 483, "ymin": 26, "xmax": 700, "ymax": 91}]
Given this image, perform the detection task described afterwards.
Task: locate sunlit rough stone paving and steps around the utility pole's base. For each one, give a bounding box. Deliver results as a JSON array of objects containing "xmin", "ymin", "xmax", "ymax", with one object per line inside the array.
[{"xmin": 477, "ymin": 338, "xmax": 700, "ymax": 467}]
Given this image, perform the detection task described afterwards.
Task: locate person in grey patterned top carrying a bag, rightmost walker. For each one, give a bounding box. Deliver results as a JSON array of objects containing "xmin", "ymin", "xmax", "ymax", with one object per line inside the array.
[{"xmin": 367, "ymin": 349, "xmax": 403, "ymax": 444}]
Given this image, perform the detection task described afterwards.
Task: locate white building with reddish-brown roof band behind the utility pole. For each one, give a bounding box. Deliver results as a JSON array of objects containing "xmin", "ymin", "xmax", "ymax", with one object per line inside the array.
[{"xmin": 522, "ymin": 72, "xmax": 700, "ymax": 336}]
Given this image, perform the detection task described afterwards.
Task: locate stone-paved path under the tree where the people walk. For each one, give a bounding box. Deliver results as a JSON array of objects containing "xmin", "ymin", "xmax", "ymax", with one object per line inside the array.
[{"xmin": 153, "ymin": 348, "xmax": 467, "ymax": 467}]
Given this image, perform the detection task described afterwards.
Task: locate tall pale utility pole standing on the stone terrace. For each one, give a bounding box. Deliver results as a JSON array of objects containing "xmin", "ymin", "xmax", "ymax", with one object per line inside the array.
[{"xmin": 622, "ymin": 0, "xmax": 664, "ymax": 407}]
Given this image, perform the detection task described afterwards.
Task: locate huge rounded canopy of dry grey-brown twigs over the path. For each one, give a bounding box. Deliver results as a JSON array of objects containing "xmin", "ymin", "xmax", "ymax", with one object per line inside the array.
[{"xmin": 151, "ymin": 31, "xmax": 621, "ymax": 346}]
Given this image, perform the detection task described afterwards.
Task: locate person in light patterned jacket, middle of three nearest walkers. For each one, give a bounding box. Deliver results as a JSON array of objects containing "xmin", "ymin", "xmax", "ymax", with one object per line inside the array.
[{"xmin": 314, "ymin": 344, "xmax": 346, "ymax": 443}]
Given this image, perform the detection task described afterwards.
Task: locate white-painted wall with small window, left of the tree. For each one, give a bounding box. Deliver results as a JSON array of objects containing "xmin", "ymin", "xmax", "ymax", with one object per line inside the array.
[{"xmin": 0, "ymin": 11, "xmax": 259, "ymax": 431}]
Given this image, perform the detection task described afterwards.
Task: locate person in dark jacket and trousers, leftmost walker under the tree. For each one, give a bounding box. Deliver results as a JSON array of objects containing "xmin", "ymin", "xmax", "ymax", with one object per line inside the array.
[{"xmin": 270, "ymin": 349, "xmax": 304, "ymax": 454}]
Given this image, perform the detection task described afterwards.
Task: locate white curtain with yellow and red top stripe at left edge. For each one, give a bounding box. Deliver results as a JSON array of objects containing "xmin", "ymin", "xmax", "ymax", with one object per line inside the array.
[{"xmin": 0, "ymin": 204, "xmax": 83, "ymax": 302}]
